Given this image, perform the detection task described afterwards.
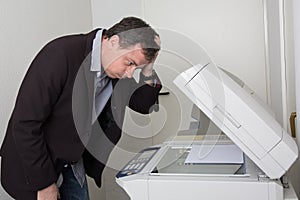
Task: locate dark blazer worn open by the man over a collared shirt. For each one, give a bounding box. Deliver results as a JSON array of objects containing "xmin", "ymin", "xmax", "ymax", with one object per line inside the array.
[{"xmin": 0, "ymin": 30, "xmax": 161, "ymax": 199}]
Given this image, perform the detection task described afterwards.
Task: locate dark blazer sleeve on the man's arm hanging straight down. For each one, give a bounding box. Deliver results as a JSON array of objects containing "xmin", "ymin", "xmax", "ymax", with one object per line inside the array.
[{"xmin": 11, "ymin": 43, "xmax": 67, "ymax": 191}]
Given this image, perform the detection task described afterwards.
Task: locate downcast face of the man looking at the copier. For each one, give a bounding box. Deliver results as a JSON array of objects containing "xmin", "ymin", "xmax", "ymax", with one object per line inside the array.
[{"xmin": 102, "ymin": 35, "xmax": 148, "ymax": 79}]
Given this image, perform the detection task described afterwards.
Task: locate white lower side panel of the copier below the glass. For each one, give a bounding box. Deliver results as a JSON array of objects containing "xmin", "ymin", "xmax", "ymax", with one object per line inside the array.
[{"xmin": 148, "ymin": 177, "xmax": 283, "ymax": 200}]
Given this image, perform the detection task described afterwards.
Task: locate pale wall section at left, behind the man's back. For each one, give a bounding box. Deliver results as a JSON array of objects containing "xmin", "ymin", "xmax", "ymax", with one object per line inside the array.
[{"xmin": 0, "ymin": 0, "xmax": 92, "ymax": 200}]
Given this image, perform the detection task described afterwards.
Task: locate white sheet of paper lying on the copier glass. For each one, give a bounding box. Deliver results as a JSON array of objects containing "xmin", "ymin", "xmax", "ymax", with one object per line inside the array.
[{"xmin": 185, "ymin": 144, "xmax": 244, "ymax": 164}]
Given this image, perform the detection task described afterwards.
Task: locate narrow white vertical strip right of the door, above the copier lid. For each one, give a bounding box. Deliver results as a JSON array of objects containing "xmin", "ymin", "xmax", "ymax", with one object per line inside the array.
[{"xmin": 265, "ymin": 0, "xmax": 287, "ymax": 128}]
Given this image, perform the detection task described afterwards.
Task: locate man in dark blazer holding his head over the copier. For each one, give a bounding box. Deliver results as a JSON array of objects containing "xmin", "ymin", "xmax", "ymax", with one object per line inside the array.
[{"xmin": 1, "ymin": 17, "xmax": 161, "ymax": 200}]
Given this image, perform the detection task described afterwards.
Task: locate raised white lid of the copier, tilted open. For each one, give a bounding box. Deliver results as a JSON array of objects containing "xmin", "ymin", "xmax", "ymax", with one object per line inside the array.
[{"xmin": 174, "ymin": 63, "xmax": 298, "ymax": 178}]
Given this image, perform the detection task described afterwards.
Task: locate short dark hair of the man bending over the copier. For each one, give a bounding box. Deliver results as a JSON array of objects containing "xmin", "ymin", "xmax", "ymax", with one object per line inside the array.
[{"xmin": 104, "ymin": 17, "xmax": 160, "ymax": 62}]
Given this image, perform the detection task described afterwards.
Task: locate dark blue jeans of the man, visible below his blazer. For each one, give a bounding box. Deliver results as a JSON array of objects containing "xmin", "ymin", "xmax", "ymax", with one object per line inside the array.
[{"xmin": 59, "ymin": 166, "xmax": 90, "ymax": 200}]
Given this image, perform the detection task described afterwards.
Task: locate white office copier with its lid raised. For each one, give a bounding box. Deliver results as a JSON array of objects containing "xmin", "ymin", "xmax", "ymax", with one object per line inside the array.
[{"xmin": 116, "ymin": 63, "xmax": 298, "ymax": 200}]
